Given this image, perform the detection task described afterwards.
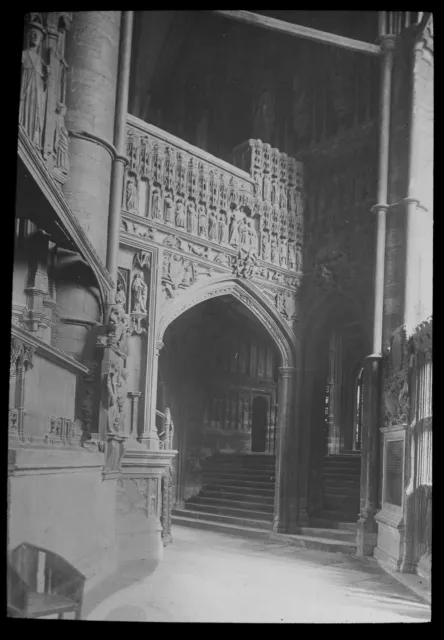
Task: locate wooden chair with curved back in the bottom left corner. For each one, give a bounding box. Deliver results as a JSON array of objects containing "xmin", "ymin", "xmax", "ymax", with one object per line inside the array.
[{"xmin": 7, "ymin": 543, "xmax": 85, "ymax": 620}]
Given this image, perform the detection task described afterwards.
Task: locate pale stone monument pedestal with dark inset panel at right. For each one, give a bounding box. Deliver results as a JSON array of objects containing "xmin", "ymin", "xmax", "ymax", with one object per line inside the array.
[{"xmin": 374, "ymin": 424, "xmax": 407, "ymax": 571}]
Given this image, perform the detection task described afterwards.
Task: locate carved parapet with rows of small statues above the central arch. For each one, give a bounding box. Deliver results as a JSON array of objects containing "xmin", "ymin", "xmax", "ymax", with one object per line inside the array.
[{"xmin": 123, "ymin": 126, "xmax": 303, "ymax": 271}]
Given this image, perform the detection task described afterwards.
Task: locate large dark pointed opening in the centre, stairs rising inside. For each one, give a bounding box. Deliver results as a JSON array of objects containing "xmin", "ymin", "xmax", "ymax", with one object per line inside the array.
[{"xmin": 157, "ymin": 294, "xmax": 281, "ymax": 528}]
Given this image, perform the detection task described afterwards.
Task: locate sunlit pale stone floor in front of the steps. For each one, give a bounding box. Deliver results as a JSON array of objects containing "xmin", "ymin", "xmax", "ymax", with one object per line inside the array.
[{"xmin": 84, "ymin": 526, "xmax": 431, "ymax": 623}]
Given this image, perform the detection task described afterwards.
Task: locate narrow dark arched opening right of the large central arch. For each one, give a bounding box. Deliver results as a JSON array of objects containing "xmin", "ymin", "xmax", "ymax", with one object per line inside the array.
[{"xmin": 301, "ymin": 297, "xmax": 369, "ymax": 522}]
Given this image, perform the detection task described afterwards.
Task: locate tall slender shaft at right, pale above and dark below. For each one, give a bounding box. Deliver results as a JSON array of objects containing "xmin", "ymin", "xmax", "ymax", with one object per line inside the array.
[{"xmin": 356, "ymin": 35, "xmax": 395, "ymax": 556}]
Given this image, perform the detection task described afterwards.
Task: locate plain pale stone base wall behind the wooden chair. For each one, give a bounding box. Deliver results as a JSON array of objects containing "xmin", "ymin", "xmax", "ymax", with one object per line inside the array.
[{"xmin": 9, "ymin": 449, "xmax": 116, "ymax": 579}]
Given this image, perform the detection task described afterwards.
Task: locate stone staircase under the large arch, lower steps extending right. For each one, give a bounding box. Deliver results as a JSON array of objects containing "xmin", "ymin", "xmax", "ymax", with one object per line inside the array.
[{"xmin": 172, "ymin": 454, "xmax": 357, "ymax": 554}]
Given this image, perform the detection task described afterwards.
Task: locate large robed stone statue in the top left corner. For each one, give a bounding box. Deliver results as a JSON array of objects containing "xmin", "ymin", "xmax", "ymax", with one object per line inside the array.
[{"xmin": 19, "ymin": 14, "xmax": 49, "ymax": 149}]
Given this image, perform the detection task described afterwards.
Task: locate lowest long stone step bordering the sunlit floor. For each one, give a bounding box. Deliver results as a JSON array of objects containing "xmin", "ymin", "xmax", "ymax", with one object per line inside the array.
[{"xmin": 172, "ymin": 513, "xmax": 356, "ymax": 555}]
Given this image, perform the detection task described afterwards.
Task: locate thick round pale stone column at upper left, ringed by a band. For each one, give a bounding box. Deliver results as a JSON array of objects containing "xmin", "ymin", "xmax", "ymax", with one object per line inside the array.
[{"xmin": 63, "ymin": 11, "xmax": 121, "ymax": 264}]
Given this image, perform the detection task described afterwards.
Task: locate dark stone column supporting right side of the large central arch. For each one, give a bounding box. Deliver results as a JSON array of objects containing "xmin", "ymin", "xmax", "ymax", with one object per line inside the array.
[{"xmin": 273, "ymin": 367, "xmax": 297, "ymax": 533}]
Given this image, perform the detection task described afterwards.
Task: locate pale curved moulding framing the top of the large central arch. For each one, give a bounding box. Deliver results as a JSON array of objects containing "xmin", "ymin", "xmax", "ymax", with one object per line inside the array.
[{"xmin": 156, "ymin": 277, "xmax": 299, "ymax": 368}]
